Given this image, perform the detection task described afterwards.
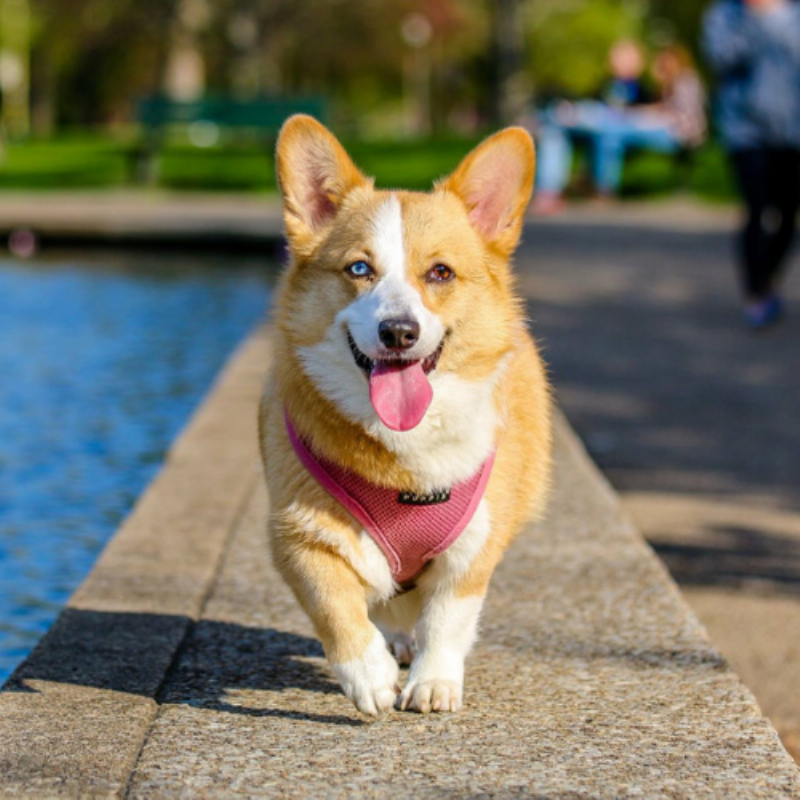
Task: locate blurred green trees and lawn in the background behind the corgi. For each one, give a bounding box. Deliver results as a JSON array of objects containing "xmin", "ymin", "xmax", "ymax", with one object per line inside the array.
[{"xmin": 0, "ymin": 0, "xmax": 729, "ymax": 196}]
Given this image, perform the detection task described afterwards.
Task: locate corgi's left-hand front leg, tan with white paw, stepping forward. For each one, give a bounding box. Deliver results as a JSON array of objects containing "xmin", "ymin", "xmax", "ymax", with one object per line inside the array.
[{"xmin": 275, "ymin": 544, "xmax": 398, "ymax": 716}]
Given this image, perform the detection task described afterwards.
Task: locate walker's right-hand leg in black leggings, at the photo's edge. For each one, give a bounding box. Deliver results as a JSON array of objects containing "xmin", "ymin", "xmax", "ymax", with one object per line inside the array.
[{"xmin": 767, "ymin": 150, "xmax": 800, "ymax": 292}]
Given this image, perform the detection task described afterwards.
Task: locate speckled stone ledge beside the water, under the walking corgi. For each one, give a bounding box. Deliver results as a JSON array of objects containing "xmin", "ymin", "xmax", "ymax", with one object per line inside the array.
[{"xmin": 0, "ymin": 332, "xmax": 800, "ymax": 798}]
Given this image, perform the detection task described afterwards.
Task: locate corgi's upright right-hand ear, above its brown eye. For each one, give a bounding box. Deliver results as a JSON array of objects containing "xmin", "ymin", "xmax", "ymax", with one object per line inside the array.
[{"xmin": 437, "ymin": 128, "xmax": 536, "ymax": 256}]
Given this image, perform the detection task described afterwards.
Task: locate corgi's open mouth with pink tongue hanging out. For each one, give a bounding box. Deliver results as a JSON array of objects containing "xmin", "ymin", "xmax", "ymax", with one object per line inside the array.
[{"xmin": 347, "ymin": 331, "xmax": 444, "ymax": 431}]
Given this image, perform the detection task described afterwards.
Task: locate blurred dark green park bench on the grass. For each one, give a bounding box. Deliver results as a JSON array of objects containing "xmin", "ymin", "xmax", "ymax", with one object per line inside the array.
[{"xmin": 132, "ymin": 96, "xmax": 326, "ymax": 183}]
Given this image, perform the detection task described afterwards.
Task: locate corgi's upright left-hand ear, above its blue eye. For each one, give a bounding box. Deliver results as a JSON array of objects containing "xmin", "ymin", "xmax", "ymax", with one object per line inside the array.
[{"xmin": 276, "ymin": 114, "xmax": 368, "ymax": 244}]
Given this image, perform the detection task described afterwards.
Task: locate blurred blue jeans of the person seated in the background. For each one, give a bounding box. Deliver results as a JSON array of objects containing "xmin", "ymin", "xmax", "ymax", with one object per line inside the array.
[{"xmin": 536, "ymin": 103, "xmax": 681, "ymax": 194}]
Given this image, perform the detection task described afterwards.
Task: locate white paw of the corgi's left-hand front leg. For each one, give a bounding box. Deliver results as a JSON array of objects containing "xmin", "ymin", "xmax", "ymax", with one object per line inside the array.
[{"xmin": 333, "ymin": 633, "xmax": 400, "ymax": 717}]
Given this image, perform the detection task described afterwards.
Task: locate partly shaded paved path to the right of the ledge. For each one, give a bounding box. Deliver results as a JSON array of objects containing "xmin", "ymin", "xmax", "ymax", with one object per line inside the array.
[{"xmin": 519, "ymin": 205, "xmax": 800, "ymax": 760}]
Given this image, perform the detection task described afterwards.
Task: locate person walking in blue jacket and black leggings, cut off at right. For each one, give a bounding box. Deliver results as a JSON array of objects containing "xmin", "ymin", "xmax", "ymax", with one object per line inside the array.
[{"xmin": 704, "ymin": 0, "xmax": 800, "ymax": 329}]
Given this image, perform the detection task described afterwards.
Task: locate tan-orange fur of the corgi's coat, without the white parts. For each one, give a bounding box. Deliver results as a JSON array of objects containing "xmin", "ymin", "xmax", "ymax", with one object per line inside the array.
[{"xmin": 260, "ymin": 117, "xmax": 551, "ymax": 716}]
